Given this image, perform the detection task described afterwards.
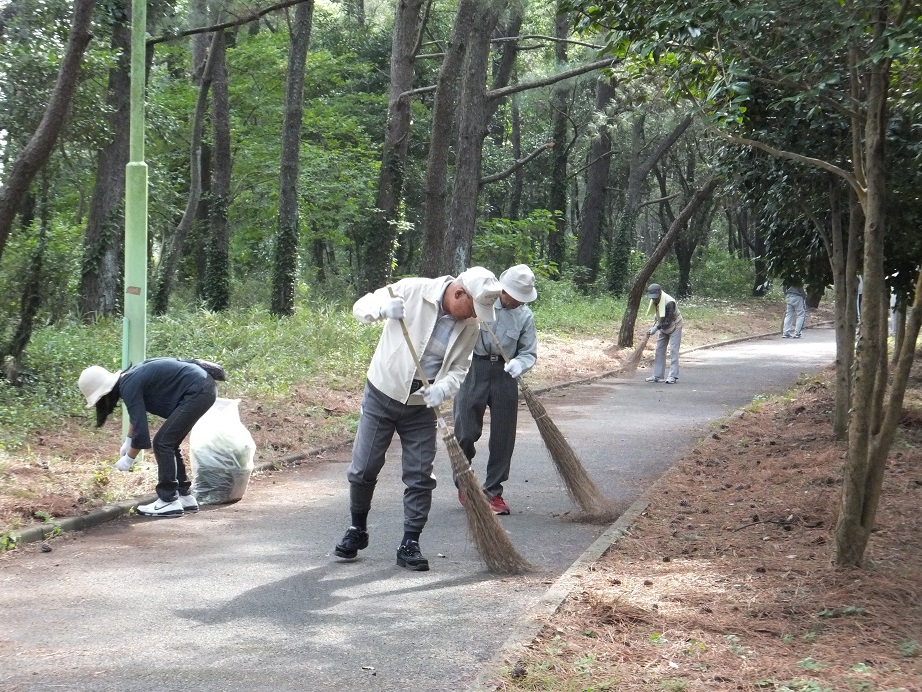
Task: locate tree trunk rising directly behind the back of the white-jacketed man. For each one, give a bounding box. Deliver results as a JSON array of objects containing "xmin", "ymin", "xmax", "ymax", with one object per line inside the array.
[{"xmin": 358, "ymin": 0, "xmax": 423, "ymax": 295}]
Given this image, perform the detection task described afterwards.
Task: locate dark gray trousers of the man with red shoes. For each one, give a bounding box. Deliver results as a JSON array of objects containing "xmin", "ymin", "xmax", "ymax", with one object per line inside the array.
[{"xmin": 454, "ymin": 357, "xmax": 519, "ymax": 497}]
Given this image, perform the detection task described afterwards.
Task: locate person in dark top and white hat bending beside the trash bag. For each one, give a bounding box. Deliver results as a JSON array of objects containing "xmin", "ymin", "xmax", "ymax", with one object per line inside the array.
[{"xmin": 77, "ymin": 358, "xmax": 217, "ymax": 517}]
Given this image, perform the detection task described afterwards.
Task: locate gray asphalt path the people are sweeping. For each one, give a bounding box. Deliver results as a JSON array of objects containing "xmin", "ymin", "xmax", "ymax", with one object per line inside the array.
[{"xmin": 0, "ymin": 329, "xmax": 834, "ymax": 692}]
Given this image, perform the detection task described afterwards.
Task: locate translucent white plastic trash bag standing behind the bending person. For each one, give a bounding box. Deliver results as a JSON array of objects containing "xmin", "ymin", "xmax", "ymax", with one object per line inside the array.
[{"xmin": 189, "ymin": 398, "xmax": 256, "ymax": 505}]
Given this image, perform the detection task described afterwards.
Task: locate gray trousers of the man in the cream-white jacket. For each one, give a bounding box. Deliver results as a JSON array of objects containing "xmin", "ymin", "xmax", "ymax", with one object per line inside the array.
[{"xmin": 346, "ymin": 382, "xmax": 436, "ymax": 531}]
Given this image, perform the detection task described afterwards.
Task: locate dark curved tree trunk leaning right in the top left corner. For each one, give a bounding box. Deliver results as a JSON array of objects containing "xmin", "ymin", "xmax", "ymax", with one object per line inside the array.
[{"xmin": 0, "ymin": 0, "xmax": 96, "ymax": 258}]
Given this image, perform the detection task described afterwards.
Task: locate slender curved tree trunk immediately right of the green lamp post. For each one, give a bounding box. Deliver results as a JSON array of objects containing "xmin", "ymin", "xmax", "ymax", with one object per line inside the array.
[{"xmin": 151, "ymin": 32, "xmax": 220, "ymax": 315}]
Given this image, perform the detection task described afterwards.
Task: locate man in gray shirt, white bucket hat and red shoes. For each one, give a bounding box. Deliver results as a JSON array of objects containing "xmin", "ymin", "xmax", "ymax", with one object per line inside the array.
[{"xmin": 454, "ymin": 264, "xmax": 538, "ymax": 514}]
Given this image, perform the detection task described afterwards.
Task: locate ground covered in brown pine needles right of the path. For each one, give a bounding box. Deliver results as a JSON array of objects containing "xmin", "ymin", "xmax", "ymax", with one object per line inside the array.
[{"xmin": 497, "ymin": 359, "xmax": 922, "ymax": 692}]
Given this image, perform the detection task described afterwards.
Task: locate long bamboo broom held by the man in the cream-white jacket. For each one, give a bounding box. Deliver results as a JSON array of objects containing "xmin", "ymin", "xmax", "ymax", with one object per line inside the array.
[{"xmin": 387, "ymin": 286, "xmax": 534, "ymax": 574}]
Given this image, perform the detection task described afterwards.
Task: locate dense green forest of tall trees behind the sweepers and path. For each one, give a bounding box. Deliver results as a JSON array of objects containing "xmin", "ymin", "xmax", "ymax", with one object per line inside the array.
[{"xmin": 0, "ymin": 0, "xmax": 922, "ymax": 620}]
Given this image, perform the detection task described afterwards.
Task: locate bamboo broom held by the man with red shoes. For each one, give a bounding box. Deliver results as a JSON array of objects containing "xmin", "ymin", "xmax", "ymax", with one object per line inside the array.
[{"xmin": 474, "ymin": 322, "xmax": 611, "ymax": 516}]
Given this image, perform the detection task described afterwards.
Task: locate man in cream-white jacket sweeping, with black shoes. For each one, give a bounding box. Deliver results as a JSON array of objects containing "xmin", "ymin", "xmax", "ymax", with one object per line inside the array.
[{"xmin": 334, "ymin": 267, "xmax": 501, "ymax": 571}]
